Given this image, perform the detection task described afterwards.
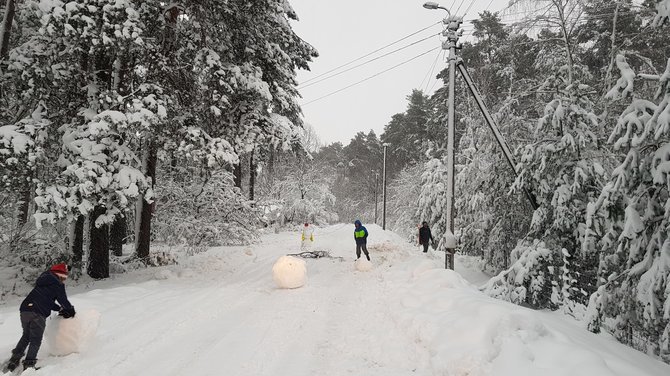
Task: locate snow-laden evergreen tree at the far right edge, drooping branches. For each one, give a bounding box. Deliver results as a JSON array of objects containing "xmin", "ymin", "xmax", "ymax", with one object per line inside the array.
[{"xmin": 587, "ymin": 55, "xmax": 670, "ymax": 361}]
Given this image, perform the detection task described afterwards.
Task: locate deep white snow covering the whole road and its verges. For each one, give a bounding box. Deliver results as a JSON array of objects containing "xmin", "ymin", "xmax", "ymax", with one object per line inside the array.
[{"xmin": 0, "ymin": 224, "xmax": 670, "ymax": 376}]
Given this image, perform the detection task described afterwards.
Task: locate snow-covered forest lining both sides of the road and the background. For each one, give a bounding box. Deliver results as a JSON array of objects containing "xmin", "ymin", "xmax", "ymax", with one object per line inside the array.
[{"xmin": 0, "ymin": 0, "xmax": 670, "ymax": 362}]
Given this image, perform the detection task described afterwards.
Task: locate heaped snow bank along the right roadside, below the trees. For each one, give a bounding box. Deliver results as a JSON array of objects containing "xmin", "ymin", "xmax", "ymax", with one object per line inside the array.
[{"xmin": 386, "ymin": 260, "xmax": 656, "ymax": 376}]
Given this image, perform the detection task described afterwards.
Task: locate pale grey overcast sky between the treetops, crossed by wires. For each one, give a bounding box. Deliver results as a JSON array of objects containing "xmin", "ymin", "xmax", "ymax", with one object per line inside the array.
[{"xmin": 290, "ymin": 0, "xmax": 508, "ymax": 145}]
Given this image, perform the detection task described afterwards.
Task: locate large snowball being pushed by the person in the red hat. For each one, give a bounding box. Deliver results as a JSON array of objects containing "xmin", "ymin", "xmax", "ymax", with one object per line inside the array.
[{"xmin": 46, "ymin": 309, "xmax": 100, "ymax": 356}]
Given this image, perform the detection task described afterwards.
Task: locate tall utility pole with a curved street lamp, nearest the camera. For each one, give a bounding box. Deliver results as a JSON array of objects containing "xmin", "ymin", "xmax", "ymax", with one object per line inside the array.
[{"xmin": 423, "ymin": 1, "xmax": 463, "ymax": 269}]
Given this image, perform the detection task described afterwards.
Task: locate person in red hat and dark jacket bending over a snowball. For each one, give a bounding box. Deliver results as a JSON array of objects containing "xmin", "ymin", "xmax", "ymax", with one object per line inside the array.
[{"xmin": 7, "ymin": 263, "xmax": 75, "ymax": 371}]
